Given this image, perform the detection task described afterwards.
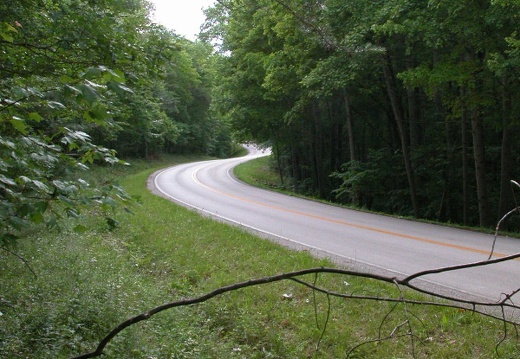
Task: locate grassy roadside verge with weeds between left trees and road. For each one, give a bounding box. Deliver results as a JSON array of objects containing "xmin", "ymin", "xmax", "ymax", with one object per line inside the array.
[{"xmin": 0, "ymin": 158, "xmax": 520, "ymax": 358}]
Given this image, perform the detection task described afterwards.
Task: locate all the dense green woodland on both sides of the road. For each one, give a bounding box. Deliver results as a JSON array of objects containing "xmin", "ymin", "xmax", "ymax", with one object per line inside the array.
[{"xmin": 0, "ymin": 0, "xmax": 520, "ymax": 244}]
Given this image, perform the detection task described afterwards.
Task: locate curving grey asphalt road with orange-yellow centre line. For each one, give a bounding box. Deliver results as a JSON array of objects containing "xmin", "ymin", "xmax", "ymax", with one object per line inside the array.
[{"xmin": 149, "ymin": 148, "xmax": 520, "ymax": 316}]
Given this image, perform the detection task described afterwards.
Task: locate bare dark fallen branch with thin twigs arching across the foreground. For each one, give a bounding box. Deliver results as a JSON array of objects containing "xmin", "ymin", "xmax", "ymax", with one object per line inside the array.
[{"xmin": 73, "ymin": 253, "xmax": 520, "ymax": 359}]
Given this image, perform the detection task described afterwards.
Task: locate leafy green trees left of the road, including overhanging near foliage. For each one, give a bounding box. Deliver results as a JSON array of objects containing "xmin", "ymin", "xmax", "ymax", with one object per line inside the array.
[{"xmin": 0, "ymin": 0, "xmax": 231, "ymax": 245}]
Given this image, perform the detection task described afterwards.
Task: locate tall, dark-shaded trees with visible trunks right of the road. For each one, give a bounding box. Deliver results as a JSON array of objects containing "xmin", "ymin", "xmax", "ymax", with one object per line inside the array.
[{"xmin": 205, "ymin": 0, "xmax": 520, "ymax": 227}]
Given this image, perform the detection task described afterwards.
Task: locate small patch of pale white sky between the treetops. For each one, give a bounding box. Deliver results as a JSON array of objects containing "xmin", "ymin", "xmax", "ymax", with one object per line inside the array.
[{"xmin": 148, "ymin": 0, "xmax": 215, "ymax": 41}]
